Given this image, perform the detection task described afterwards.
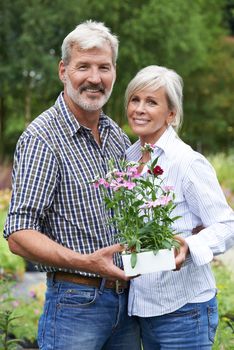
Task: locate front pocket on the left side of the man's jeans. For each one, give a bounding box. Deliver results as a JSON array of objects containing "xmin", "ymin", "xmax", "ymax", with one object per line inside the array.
[{"xmin": 59, "ymin": 287, "xmax": 98, "ymax": 308}]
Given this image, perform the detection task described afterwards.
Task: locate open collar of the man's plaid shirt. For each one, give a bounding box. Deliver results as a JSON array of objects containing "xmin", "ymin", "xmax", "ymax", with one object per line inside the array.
[{"xmin": 55, "ymin": 92, "xmax": 110, "ymax": 136}]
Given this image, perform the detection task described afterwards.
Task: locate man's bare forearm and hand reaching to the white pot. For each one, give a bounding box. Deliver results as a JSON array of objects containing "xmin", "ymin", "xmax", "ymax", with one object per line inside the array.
[{"xmin": 8, "ymin": 230, "xmax": 127, "ymax": 279}]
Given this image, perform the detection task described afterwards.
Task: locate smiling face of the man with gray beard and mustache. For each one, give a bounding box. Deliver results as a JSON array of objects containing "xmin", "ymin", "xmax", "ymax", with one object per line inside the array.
[{"xmin": 59, "ymin": 44, "xmax": 116, "ymax": 112}]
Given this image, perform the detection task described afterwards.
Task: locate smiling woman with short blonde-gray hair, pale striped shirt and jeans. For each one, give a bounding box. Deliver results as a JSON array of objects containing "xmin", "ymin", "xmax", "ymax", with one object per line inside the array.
[{"xmin": 125, "ymin": 66, "xmax": 234, "ymax": 350}]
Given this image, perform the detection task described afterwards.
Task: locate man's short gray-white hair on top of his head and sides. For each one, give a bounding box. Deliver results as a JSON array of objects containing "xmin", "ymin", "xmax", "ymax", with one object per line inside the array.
[{"xmin": 61, "ymin": 20, "xmax": 119, "ymax": 65}]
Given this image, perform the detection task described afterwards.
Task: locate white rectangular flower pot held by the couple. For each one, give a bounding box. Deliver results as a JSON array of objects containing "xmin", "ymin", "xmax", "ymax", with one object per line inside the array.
[{"xmin": 122, "ymin": 249, "xmax": 176, "ymax": 276}]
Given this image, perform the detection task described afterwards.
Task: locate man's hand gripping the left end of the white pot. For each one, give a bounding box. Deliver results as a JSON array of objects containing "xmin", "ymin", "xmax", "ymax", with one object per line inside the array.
[{"xmin": 88, "ymin": 244, "xmax": 129, "ymax": 281}]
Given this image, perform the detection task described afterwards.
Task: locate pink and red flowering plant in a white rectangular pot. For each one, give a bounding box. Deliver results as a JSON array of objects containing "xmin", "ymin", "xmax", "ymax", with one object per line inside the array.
[{"xmin": 94, "ymin": 144, "xmax": 179, "ymax": 276}]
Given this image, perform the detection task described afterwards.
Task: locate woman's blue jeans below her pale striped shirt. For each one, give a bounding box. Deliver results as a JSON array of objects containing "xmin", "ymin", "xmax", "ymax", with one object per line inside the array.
[{"xmin": 139, "ymin": 297, "xmax": 218, "ymax": 350}]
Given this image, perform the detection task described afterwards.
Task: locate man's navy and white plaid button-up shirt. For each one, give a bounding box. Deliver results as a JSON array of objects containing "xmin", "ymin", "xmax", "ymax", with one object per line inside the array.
[{"xmin": 4, "ymin": 93, "xmax": 130, "ymax": 274}]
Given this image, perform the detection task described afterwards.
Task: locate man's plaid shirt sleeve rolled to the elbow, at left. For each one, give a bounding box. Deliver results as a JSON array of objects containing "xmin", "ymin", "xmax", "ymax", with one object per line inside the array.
[{"xmin": 4, "ymin": 136, "xmax": 58, "ymax": 238}]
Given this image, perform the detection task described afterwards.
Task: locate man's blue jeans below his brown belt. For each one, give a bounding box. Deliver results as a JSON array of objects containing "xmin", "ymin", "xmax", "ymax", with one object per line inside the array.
[{"xmin": 38, "ymin": 278, "xmax": 140, "ymax": 350}]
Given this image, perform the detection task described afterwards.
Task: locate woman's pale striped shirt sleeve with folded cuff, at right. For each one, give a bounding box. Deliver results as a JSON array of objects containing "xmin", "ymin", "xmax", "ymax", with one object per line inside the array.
[{"xmin": 183, "ymin": 157, "xmax": 234, "ymax": 265}]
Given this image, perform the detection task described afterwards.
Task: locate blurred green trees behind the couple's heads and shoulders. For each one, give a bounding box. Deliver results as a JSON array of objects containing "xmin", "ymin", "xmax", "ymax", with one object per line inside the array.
[{"xmin": 0, "ymin": 0, "xmax": 234, "ymax": 163}]
